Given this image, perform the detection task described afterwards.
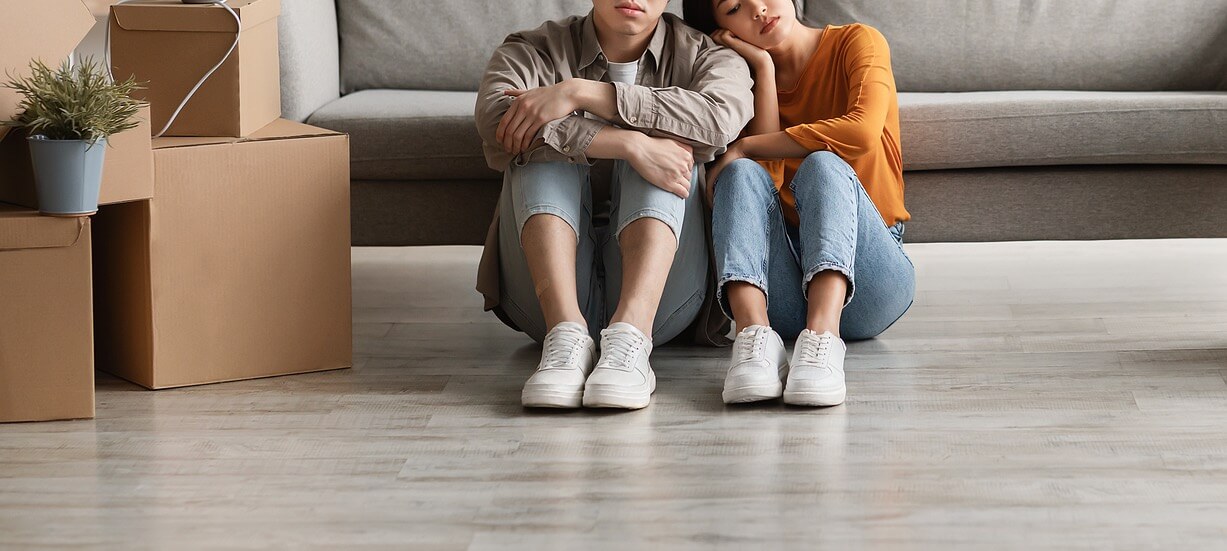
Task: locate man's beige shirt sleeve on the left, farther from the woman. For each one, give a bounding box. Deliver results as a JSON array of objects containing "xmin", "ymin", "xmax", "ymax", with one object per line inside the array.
[{"xmin": 474, "ymin": 33, "xmax": 607, "ymax": 172}]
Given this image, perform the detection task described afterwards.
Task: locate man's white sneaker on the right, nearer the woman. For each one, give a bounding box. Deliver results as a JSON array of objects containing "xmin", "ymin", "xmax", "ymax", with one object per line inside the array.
[{"xmin": 584, "ymin": 322, "xmax": 656, "ymax": 410}]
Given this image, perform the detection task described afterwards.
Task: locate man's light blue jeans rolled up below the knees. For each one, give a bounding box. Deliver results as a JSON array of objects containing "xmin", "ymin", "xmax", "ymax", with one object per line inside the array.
[{"xmin": 498, "ymin": 161, "xmax": 709, "ymax": 345}]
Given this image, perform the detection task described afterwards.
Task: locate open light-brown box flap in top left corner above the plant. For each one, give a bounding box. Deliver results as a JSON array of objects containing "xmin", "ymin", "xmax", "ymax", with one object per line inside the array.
[{"xmin": 0, "ymin": 0, "xmax": 95, "ymax": 137}]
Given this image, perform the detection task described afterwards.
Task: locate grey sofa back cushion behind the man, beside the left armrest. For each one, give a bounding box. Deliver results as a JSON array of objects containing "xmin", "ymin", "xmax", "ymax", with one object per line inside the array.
[{"xmin": 336, "ymin": 0, "xmax": 681, "ymax": 92}]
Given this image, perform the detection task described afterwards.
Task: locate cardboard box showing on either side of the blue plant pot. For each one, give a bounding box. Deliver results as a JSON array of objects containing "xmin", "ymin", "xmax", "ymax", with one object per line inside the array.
[{"xmin": 0, "ymin": 101, "xmax": 153, "ymax": 209}]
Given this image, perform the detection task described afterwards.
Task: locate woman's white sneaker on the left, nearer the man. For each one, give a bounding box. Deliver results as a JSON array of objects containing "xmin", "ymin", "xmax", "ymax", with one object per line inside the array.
[{"xmin": 723, "ymin": 325, "xmax": 788, "ymax": 404}]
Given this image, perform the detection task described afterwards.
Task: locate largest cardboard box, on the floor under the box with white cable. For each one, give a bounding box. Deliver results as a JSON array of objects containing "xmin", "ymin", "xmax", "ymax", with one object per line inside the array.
[{"xmin": 94, "ymin": 120, "xmax": 352, "ymax": 389}]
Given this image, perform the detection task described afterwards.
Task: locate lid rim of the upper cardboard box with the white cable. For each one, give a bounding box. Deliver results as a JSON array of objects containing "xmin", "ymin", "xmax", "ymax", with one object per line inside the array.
[{"xmin": 110, "ymin": 0, "xmax": 281, "ymax": 33}]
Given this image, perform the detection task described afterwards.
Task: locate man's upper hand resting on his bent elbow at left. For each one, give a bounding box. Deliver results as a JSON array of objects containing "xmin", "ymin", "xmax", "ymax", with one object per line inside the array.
[{"xmin": 494, "ymin": 81, "xmax": 577, "ymax": 155}]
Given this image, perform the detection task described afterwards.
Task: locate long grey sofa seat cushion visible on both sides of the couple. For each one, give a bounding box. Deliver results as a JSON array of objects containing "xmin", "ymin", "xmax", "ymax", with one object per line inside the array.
[{"xmin": 308, "ymin": 90, "xmax": 1227, "ymax": 180}]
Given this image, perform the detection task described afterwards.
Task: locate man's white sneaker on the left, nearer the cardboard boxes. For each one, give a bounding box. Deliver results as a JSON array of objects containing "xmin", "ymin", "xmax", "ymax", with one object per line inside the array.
[{"xmin": 520, "ymin": 322, "xmax": 596, "ymax": 407}]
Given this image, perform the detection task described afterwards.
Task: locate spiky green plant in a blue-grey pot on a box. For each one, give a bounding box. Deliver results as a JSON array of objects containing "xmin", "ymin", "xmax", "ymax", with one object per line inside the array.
[{"xmin": 0, "ymin": 59, "xmax": 140, "ymax": 216}]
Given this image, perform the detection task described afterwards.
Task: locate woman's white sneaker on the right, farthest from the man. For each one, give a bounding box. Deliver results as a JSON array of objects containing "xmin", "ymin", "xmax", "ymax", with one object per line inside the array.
[{"xmin": 784, "ymin": 329, "xmax": 848, "ymax": 406}]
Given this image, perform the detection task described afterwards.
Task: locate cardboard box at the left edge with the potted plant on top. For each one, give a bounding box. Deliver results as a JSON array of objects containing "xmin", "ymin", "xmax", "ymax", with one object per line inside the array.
[{"xmin": 0, "ymin": 205, "xmax": 93, "ymax": 422}]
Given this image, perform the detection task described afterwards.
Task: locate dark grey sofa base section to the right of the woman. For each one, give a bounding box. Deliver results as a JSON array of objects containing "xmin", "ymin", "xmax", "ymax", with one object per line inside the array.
[{"xmin": 904, "ymin": 164, "xmax": 1227, "ymax": 243}]
